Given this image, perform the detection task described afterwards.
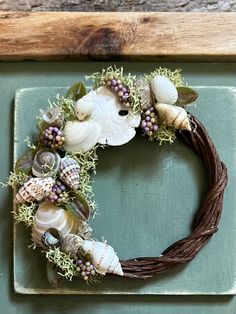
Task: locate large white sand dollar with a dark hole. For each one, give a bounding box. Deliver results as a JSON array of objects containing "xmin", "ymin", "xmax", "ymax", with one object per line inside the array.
[{"xmin": 91, "ymin": 86, "xmax": 141, "ymax": 146}]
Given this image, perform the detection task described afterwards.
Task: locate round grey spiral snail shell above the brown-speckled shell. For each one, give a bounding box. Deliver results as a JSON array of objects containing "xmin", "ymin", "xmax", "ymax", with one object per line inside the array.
[{"xmin": 32, "ymin": 148, "xmax": 61, "ymax": 178}]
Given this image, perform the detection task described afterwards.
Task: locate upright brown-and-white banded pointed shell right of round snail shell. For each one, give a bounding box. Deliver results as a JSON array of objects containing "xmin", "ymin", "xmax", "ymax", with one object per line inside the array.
[{"xmin": 59, "ymin": 157, "xmax": 80, "ymax": 190}]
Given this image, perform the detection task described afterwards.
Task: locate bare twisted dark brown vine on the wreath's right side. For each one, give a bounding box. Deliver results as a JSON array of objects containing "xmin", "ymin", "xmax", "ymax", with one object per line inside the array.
[{"xmin": 121, "ymin": 114, "xmax": 228, "ymax": 279}]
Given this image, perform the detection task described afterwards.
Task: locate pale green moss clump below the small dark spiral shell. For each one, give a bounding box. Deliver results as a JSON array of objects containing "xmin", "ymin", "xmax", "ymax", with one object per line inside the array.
[{"xmin": 45, "ymin": 248, "xmax": 76, "ymax": 281}]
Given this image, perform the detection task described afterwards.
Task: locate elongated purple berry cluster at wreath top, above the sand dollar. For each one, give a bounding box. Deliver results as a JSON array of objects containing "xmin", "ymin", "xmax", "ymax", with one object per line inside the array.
[{"xmin": 102, "ymin": 75, "xmax": 131, "ymax": 108}]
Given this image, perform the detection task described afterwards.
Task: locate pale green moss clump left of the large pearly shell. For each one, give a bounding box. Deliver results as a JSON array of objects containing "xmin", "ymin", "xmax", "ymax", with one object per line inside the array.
[{"xmin": 13, "ymin": 203, "xmax": 37, "ymax": 227}]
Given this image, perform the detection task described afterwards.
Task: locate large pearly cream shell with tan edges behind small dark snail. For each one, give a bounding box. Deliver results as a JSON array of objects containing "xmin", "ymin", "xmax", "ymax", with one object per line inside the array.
[{"xmin": 32, "ymin": 201, "xmax": 78, "ymax": 246}]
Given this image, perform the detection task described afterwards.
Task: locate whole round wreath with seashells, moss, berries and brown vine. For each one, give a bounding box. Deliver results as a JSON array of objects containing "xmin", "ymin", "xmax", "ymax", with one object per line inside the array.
[{"xmin": 6, "ymin": 66, "xmax": 227, "ymax": 286}]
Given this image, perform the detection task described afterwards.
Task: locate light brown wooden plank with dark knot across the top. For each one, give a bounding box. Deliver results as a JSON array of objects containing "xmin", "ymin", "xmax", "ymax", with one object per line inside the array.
[{"xmin": 0, "ymin": 12, "xmax": 236, "ymax": 62}]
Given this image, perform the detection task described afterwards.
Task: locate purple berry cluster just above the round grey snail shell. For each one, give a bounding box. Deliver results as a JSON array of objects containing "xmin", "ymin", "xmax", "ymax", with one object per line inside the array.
[{"xmin": 43, "ymin": 126, "xmax": 65, "ymax": 149}]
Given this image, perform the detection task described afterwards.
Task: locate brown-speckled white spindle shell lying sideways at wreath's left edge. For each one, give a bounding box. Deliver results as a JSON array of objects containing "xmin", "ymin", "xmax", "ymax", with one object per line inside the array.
[{"xmin": 15, "ymin": 177, "xmax": 55, "ymax": 203}]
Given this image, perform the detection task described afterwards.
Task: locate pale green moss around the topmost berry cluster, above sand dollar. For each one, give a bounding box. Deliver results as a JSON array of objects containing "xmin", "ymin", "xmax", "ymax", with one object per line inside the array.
[{"xmin": 86, "ymin": 66, "xmax": 141, "ymax": 113}]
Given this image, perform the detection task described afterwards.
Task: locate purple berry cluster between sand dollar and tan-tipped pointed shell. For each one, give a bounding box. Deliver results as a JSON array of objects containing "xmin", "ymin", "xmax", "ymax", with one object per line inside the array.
[{"xmin": 140, "ymin": 107, "xmax": 158, "ymax": 136}]
